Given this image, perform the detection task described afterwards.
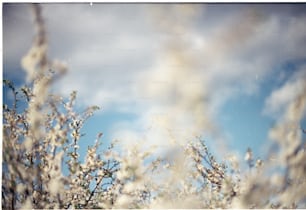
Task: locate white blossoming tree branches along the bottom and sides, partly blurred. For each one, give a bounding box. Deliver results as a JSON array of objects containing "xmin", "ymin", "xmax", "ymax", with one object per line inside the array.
[{"xmin": 2, "ymin": 4, "xmax": 306, "ymax": 209}]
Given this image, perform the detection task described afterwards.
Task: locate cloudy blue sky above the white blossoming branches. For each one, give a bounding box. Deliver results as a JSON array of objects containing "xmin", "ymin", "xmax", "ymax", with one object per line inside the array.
[{"xmin": 3, "ymin": 3, "xmax": 306, "ymax": 162}]
